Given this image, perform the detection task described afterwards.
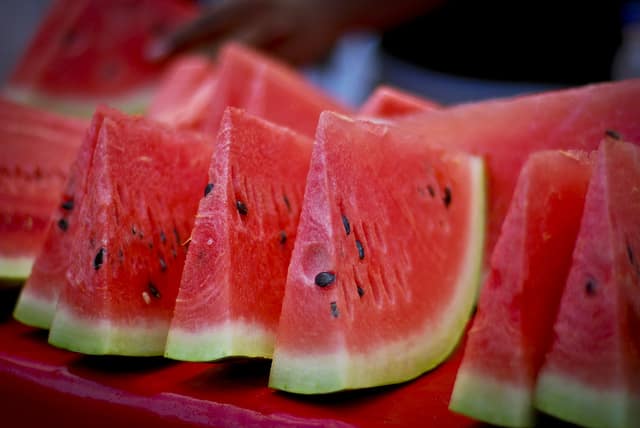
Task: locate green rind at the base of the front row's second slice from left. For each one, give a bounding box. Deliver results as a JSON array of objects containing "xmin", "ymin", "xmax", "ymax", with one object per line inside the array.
[{"xmin": 49, "ymin": 306, "xmax": 169, "ymax": 357}]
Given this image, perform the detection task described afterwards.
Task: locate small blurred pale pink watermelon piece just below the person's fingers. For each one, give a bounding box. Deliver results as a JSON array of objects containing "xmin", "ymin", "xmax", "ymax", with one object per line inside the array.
[{"xmin": 147, "ymin": 55, "xmax": 217, "ymax": 129}]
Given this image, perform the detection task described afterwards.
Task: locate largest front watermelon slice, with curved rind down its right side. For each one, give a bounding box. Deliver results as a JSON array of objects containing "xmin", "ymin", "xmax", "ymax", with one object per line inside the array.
[{"xmin": 269, "ymin": 112, "xmax": 485, "ymax": 394}]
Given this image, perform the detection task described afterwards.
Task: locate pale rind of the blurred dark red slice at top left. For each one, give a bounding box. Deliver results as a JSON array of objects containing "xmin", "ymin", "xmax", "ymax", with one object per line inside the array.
[{"xmin": 2, "ymin": 85, "xmax": 155, "ymax": 117}]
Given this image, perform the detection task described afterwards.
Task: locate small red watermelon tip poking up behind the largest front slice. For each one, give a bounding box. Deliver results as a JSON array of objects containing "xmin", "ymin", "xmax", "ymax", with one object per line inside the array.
[{"xmin": 358, "ymin": 85, "xmax": 440, "ymax": 119}]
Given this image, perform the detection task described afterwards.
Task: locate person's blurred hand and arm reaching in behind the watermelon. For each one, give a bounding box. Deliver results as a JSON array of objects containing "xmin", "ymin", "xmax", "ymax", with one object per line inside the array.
[{"xmin": 149, "ymin": 0, "xmax": 444, "ymax": 64}]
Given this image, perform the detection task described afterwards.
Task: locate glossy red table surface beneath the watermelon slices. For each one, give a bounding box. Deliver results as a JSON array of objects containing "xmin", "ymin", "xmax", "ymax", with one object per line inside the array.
[{"xmin": 0, "ymin": 291, "xmax": 572, "ymax": 428}]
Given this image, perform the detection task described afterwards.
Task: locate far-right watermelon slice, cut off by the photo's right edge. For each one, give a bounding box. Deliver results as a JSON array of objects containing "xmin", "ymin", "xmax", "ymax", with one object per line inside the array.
[{"xmin": 536, "ymin": 139, "xmax": 640, "ymax": 427}]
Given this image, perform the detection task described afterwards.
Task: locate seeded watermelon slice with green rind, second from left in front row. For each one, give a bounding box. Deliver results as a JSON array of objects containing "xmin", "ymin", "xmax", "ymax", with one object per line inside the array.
[{"xmin": 49, "ymin": 107, "xmax": 212, "ymax": 355}]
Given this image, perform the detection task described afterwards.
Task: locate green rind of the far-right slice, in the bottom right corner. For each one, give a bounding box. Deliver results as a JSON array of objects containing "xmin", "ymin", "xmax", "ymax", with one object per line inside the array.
[{"xmin": 534, "ymin": 372, "xmax": 640, "ymax": 428}]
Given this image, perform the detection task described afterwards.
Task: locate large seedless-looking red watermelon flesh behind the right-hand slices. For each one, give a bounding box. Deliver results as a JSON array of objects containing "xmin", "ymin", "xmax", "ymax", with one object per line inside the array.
[{"xmin": 400, "ymin": 79, "xmax": 640, "ymax": 262}]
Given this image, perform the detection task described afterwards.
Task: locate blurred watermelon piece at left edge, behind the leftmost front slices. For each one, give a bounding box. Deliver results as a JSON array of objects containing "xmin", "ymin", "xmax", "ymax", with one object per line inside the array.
[{"xmin": 0, "ymin": 99, "xmax": 87, "ymax": 283}]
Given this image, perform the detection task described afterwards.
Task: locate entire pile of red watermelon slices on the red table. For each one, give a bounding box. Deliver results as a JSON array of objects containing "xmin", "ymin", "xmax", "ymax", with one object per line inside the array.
[{"xmin": 0, "ymin": 0, "xmax": 640, "ymax": 427}]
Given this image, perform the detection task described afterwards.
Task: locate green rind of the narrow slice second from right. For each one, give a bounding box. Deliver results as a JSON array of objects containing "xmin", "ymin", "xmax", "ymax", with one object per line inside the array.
[{"xmin": 449, "ymin": 370, "xmax": 535, "ymax": 427}]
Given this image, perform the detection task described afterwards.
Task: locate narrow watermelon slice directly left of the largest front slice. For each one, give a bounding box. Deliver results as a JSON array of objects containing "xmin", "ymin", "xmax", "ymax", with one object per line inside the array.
[{"xmin": 165, "ymin": 108, "xmax": 312, "ymax": 361}]
